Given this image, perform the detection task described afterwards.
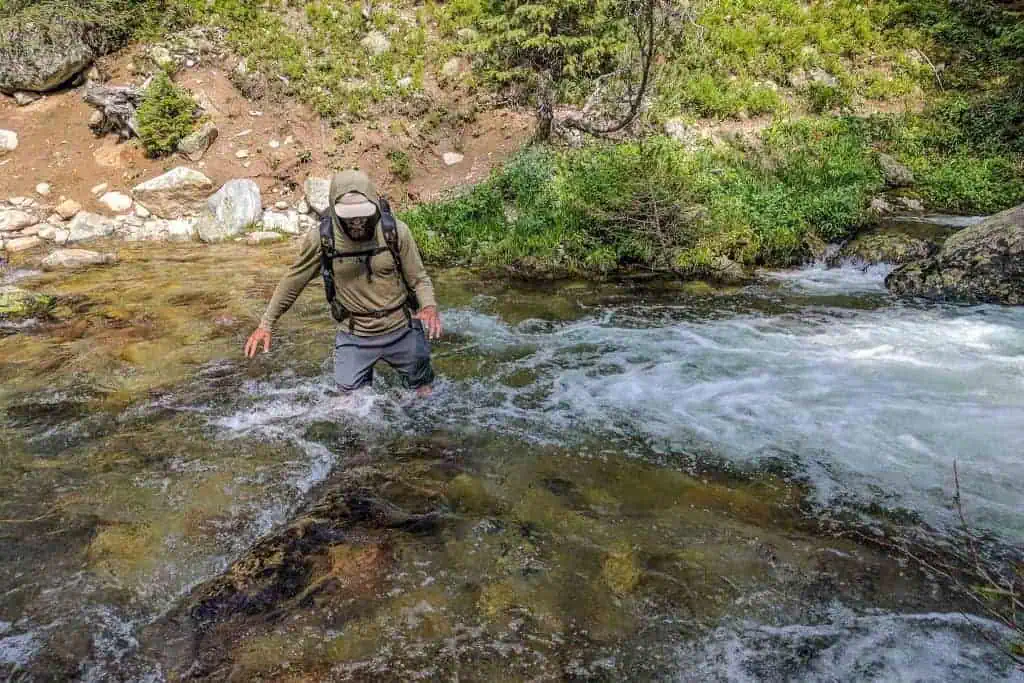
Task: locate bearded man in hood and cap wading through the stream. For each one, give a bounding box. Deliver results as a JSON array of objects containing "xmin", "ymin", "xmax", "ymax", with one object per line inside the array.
[{"xmin": 245, "ymin": 171, "xmax": 441, "ymax": 396}]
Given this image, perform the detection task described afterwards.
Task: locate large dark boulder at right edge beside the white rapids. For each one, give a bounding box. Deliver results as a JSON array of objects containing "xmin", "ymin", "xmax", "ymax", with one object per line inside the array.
[{"xmin": 886, "ymin": 205, "xmax": 1024, "ymax": 305}]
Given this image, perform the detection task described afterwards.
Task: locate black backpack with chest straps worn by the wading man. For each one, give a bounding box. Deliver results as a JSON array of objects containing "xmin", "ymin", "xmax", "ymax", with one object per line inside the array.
[{"xmin": 319, "ymin": 197, "xmax": 420, "ymax": 323}]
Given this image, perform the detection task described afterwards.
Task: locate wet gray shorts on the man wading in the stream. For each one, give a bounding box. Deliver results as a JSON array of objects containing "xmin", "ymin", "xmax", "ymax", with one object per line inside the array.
[{"xmin": 334, "ymin": 321, "xmax": 434, "ymax": 391}]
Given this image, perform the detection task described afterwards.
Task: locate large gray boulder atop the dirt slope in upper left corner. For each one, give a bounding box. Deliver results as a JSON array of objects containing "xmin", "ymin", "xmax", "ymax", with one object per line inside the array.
[{"xmin": 0, "ymin": 17, "xmax": 96, "ymax": 94}]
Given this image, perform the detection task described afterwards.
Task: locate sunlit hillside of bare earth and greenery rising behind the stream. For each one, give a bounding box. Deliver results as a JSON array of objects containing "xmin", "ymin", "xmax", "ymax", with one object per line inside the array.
[{"xmin": 0, "ymin": 0, "xmax": 1024, "ymax": 274}]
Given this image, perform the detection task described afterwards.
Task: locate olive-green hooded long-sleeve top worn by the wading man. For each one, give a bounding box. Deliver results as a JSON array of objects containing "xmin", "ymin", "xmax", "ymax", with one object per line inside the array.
[{"xmin": 260, "ymin": 171, "xmax": 437, "ymax": 337}]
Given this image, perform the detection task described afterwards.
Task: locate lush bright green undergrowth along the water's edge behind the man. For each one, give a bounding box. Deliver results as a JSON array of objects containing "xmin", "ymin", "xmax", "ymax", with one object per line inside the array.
[{"xmin": 404, "ymin": 112, "xmax": 1024, "ymax": 275}]
